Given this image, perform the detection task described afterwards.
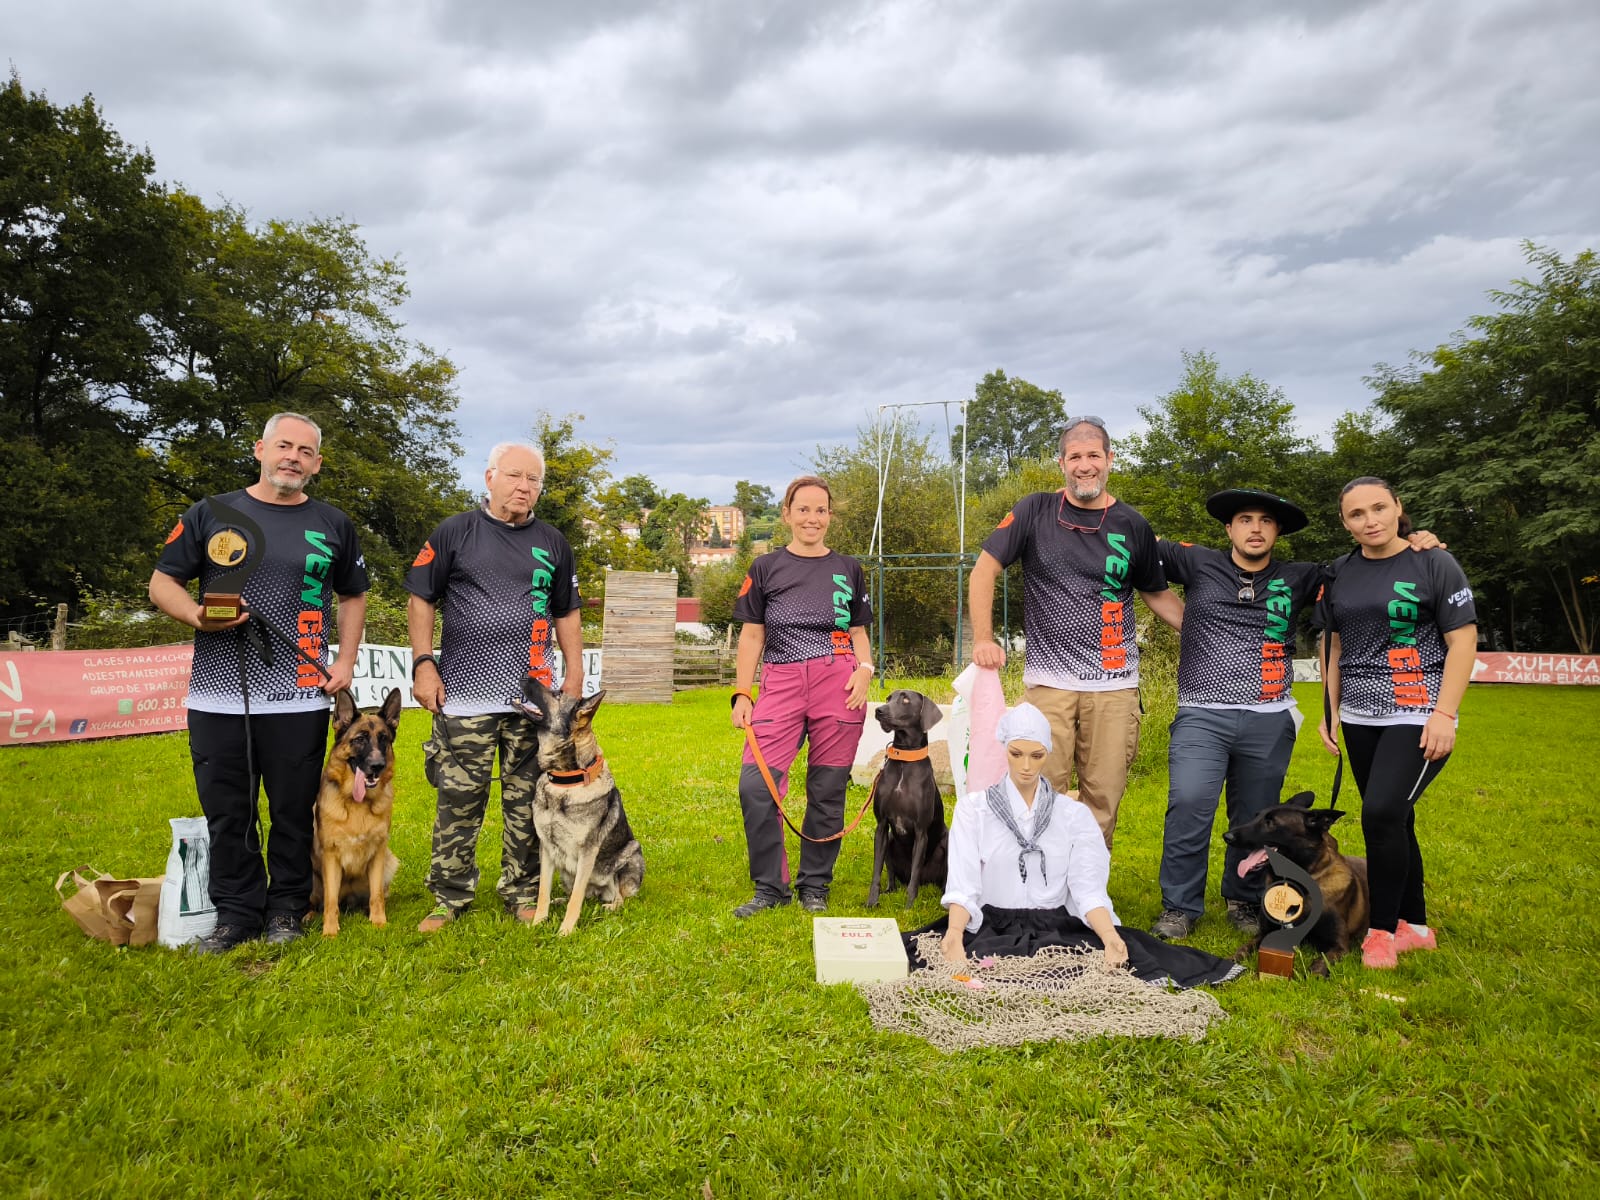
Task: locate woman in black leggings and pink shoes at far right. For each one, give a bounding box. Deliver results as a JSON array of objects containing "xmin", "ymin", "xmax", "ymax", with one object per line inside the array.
[{"xmin": 1318, "ymin": 475, "xmax": 1478, "ymax": 968}]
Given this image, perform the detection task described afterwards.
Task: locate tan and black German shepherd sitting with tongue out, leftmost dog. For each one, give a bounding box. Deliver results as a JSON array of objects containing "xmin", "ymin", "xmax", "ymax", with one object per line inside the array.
[{"xmin": 310, "ymin": 688, "xmax": 402, "ymax": 938}]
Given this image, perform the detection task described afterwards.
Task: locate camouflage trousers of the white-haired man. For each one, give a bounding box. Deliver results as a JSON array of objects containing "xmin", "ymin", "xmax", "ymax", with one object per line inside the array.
[{"xmin": 422, "ymin": 712, "xmax": 539, "ymax": 912}]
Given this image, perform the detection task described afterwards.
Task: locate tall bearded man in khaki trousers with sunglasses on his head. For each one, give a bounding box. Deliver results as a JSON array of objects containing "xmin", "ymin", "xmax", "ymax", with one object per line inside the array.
[{"xmin": 968, "ymin": 416, "xmax": 1184, "ymax": 850}]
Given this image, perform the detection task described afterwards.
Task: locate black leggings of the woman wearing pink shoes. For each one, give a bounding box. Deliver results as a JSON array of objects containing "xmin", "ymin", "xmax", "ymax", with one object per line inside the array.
[{"xmin": 1341, "ymin": 722, "xmax": 1450, "ymax": 933}]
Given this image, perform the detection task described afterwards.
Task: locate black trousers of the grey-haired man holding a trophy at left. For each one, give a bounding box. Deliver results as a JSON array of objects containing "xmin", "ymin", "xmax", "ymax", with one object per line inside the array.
[{"xmin": 189, "ymin": 709, "xmax": 328, "ymax": 931}]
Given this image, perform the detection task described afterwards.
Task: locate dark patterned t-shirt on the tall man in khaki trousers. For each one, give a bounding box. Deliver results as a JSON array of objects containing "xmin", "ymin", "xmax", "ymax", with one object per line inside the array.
[{"xmin": 984, "ymin": 491, "xmax": 1166, "ymax": 691}]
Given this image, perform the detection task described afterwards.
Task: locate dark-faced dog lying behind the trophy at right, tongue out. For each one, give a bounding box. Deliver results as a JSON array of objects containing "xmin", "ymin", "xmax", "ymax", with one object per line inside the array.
[{"xmin": 1222, "ymin": 792, "xmax": 1371, "ymax": 974}]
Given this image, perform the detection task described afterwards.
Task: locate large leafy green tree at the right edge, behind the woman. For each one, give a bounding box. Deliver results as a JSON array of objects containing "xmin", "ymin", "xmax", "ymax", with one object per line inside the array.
[{"xmin": 1371, "ymin": 243, "xmax": 1600, "ymax": 653}]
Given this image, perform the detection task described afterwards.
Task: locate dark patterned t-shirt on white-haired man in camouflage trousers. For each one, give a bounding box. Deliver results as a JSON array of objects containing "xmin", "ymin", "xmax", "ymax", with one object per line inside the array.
[{"xmin": 405, "ymin": 509, "xmax": 579, "ymax": 717}]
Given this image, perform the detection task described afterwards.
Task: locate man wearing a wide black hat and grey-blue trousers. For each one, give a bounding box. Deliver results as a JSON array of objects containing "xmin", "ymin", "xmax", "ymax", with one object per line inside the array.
[{"xmin": 1150, "ymin": 488, "xmax": 1438, "ymax": 941}]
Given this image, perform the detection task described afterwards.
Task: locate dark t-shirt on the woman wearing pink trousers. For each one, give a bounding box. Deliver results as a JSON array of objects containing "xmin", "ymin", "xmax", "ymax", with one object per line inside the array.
[{"xmin": 733, "ymin": 549, "xmax": 872, "ymax": 662}]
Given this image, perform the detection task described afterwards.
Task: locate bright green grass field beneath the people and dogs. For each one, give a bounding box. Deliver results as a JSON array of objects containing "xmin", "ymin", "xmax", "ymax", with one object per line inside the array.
[{"xmin": 0, "ymin": 686, "xmax": 1600, "ymax": 1198}]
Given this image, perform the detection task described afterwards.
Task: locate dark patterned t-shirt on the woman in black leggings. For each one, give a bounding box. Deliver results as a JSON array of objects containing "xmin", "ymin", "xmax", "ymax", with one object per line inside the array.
[{"xmin": 1317, "ymin": 550, "xmax": 1478, "ymax": 725}]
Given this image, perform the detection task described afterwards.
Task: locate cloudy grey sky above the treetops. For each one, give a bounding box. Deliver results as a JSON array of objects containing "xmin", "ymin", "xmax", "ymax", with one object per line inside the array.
[{"xmin": 0, "ymin": 0, "xmax": 1600, "ymax": 501}]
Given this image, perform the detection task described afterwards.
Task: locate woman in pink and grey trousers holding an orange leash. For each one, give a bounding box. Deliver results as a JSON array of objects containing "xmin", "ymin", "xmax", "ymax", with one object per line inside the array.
[{"xmin": 733, "ymin": 475, "xmax": 874, "ymax": 917}]
